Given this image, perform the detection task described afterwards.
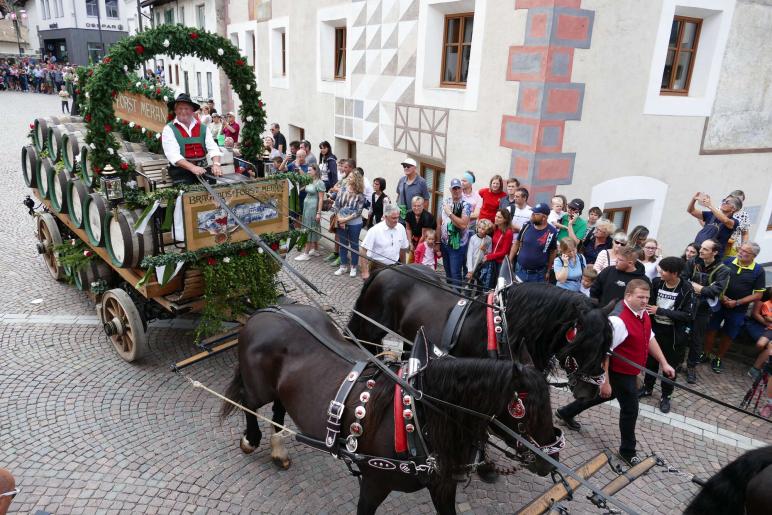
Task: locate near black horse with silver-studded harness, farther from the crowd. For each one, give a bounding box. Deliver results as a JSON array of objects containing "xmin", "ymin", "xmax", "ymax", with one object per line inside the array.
[{"xmin": 222, "ymin": 305, "xmax": 560, "ymax": 514}]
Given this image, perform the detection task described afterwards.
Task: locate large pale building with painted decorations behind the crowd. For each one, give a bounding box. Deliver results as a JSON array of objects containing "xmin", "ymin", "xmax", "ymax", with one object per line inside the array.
[{"xmin": 243, "ymin": 0, "xmax": 772, "ymax": 262}]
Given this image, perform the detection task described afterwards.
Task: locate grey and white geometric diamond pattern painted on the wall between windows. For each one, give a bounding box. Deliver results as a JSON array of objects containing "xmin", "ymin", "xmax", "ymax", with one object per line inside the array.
[{"xmin": 334, "ymin": 0, "xmax": 419, "ymax": 149}]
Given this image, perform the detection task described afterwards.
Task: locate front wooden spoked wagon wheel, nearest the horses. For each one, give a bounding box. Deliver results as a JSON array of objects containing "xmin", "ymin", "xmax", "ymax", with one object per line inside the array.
[{"xmin": 102, "ymin": 288, "xmax": 147, "ymax": 363}]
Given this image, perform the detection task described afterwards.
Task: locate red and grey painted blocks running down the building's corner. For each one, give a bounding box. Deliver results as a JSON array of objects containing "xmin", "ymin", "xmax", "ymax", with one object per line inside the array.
[{"xmin": 501, "ymin": 0, "xmax": 595, "ymax": 206}]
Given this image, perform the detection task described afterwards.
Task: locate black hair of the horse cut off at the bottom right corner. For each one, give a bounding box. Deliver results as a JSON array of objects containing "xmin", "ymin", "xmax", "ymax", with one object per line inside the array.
[{"xmin": 684, "ymin": 445, "xmax": 772, "ymax": 515}]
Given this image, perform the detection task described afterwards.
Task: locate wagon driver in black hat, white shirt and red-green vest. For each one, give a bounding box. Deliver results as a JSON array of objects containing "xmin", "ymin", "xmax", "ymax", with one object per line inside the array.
[{"xmin": 161, "ymin": 93, "xmax": 222, "ymax": 184}]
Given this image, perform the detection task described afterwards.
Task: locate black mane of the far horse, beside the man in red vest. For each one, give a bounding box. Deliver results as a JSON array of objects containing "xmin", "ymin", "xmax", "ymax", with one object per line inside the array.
[{"xmin": 507, "ymin": 283, "xmax": 612, "ymax": 375}]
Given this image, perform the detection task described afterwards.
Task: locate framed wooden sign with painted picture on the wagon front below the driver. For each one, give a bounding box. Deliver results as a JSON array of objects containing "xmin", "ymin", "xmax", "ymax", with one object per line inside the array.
[{"xmin": 182, "ymin": 181, "xmax": 289, "ymax": 251}]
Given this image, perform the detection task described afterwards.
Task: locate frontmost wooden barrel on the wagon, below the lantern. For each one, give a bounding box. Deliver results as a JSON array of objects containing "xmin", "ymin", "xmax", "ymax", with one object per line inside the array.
[{"xmin": 102, "ymin": 208, "xmax": 153, "ymax": 268}]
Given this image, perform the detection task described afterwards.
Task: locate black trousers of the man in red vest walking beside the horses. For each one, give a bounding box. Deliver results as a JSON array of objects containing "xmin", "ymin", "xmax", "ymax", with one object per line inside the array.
[{"xmin": 560, "ymin": 371, "xmax": 638, "ymax": 458}]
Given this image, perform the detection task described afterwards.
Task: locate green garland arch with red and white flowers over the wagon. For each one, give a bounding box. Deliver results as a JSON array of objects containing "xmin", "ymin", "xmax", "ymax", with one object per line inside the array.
[{"xmin": 80, "ymin": 25, "xmax": 265, "ymax": 179}]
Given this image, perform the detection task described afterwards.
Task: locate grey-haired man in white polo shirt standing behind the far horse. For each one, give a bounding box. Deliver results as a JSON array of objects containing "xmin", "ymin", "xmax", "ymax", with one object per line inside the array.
[{"xmin": 360, "ymin": 204, "xmax": 410, "ymax": 279}]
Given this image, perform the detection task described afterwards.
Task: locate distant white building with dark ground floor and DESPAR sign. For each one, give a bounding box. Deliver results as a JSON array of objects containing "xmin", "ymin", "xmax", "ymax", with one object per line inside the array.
[{"xmin": 27, "ymin": 0, "xmax": 128, "ymax": 65}]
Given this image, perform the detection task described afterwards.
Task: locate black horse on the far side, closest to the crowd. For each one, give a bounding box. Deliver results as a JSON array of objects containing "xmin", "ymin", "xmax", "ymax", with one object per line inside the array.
[{"xmin": 348, "ymin": 265, "xmax": 611, "ymax": 399}]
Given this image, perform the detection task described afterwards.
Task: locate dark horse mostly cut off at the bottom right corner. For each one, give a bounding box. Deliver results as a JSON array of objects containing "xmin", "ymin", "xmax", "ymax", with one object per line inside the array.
[{"xmin": 684, "ymin": 445, "xmax": 772, "ymax": 515}]
